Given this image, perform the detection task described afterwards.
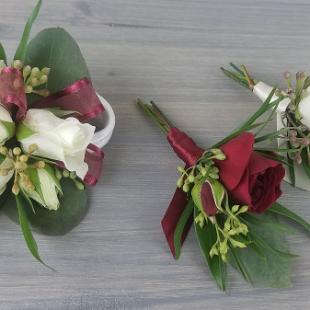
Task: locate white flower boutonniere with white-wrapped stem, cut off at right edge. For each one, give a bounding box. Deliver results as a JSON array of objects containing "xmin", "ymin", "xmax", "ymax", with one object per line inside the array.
[{"xmin": 221, "ymin": 63, "xmax": 310, "ymax": 191}]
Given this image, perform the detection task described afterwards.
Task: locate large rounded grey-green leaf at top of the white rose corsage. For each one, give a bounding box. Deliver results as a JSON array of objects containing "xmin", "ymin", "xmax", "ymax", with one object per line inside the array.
[{"xmin": 25, "ymin": 28, "xmax": 90, "ymax": 93}]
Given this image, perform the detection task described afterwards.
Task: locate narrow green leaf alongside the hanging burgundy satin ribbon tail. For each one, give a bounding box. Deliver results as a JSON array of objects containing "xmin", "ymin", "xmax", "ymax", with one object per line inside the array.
[{"xmin": 173, "ymin": 200, "xmax": 194, "ymax": 259}]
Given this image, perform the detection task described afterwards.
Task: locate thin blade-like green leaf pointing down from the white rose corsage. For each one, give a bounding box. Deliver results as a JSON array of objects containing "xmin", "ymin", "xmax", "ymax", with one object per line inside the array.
[{"xmin": 15, "ymin": 195, "xmax": 44, "ymax": 264}]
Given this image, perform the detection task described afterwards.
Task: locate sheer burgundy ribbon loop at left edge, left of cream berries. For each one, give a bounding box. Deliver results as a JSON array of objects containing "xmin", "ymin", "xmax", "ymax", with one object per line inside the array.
[{"xmin": 0, "ymin": 67, "xmax": 27, "ymax": 121}]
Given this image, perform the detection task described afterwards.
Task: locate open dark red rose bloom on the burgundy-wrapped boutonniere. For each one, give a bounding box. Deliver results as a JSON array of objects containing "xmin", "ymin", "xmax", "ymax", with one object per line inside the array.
[{"xmin": 217, "ymin": 132, "xmax": 285, "ymax": 213}]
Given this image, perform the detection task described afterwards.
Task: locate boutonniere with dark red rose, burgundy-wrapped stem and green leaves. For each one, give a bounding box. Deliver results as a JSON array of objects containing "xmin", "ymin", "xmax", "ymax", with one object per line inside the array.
[{"xmin": 138, "ymin": 97, "xmax": 310, "ymax": 290}]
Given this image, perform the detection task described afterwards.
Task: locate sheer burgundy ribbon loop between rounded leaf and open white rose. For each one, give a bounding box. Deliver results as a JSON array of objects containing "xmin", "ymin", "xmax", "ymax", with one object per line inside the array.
[{"xmin": 32, "ymin": 78, "xmax": 104, "ymax": 122}]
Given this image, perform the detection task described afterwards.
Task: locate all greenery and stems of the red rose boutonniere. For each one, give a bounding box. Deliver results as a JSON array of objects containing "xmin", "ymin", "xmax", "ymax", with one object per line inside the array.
[{"xmin": 137, "ymin": 95, "xmax": 310, "ymax": 290}]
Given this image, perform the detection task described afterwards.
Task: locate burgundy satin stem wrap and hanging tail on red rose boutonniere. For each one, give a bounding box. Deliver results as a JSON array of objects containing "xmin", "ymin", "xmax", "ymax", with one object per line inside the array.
[{"xmin": 161, "ymin": 128, "xmax": 204, "ymax": 257}]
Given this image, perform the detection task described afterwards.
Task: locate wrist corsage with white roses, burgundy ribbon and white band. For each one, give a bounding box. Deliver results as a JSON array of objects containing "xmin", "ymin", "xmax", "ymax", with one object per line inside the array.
[{"xmin": 0, "ymin": 1, "xmax": 115, "ymax": 262}]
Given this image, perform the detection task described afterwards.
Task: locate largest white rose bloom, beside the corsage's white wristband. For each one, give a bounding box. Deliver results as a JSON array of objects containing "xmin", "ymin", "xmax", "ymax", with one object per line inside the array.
[{"xmin": 17, "ymin": 109, "xmax": 95, "ymax": 179}]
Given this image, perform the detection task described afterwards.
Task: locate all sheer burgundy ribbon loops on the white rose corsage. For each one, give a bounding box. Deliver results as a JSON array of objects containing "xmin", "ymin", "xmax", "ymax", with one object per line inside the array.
[{"xmin": 0, "ymin": 67, "xmax": 104, "ymax": 185}]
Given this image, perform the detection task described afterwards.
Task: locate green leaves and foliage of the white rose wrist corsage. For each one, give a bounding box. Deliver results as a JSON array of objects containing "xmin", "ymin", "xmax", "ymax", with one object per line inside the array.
[{"xmin": 0, "ymin": 0, "xmax": 95, "ymax": 263}]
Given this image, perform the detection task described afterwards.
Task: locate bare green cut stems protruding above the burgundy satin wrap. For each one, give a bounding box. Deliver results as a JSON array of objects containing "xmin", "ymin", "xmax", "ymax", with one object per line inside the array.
[{"xmin": 137, "ymin": 99, "xmax": 172, "ymax": 134}]
